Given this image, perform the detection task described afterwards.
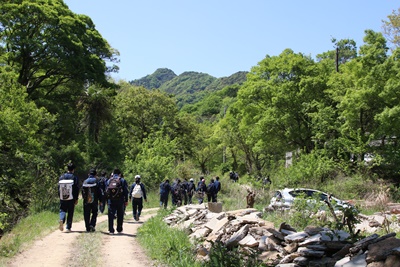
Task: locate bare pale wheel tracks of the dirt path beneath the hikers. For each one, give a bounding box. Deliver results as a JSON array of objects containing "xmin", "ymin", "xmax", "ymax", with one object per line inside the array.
[{"xmin": 7, "ymin": 208, "xmax": 158, "ymax": 267}]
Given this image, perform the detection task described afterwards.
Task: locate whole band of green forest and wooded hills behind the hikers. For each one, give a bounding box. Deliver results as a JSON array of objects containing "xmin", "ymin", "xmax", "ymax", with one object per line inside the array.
[{"xmin": 0, "ymin": 0, "xmax": 400, "ymax": 230}]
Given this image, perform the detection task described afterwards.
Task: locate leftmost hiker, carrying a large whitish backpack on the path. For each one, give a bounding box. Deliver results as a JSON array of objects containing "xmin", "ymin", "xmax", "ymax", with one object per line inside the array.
[{"xmin": 58, "ymin": 163, "xmax": 79, "ymax": 232}]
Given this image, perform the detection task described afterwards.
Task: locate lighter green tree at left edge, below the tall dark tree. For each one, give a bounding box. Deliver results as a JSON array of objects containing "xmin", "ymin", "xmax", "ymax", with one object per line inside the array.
[{"xmin": 0, "ymin": 67, "xmax": 54, "ymax": 228}]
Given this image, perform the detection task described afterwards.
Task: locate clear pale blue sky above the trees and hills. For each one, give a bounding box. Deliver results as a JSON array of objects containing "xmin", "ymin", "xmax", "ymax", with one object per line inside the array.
[{"xmin": 64, "ymin": 0, "xmax": 400, "ymax": 81}]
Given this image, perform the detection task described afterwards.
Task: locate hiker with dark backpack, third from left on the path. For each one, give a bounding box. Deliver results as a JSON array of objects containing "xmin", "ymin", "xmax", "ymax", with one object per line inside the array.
[{"xmin": 106, "ymin": 169, "xmax": 128, "ymax": 234}]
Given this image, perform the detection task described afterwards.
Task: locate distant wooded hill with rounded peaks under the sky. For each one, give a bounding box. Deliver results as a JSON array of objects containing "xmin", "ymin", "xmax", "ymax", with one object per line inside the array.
[{"xmin": 130, "ymin": 68, "xmax": 247, "ymax": 108}]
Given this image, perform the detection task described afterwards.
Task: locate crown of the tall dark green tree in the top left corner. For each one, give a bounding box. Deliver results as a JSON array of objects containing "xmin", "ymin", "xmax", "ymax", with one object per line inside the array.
[{"xmin": 0, "ymin": 0, "xmax": 118, "ymax": 99}]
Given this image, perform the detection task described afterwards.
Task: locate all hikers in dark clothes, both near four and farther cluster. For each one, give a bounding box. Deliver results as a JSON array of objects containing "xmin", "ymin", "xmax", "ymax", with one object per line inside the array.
[{"xmin": 58, "ymin": 163, "xmax": 228, "ymax": 234}]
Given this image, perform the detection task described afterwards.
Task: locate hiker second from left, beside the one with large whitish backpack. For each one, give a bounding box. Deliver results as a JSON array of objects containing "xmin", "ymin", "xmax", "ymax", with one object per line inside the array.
[{"xmin": 82, "ymin": 169, "xmax": 103, "ymax": 232}]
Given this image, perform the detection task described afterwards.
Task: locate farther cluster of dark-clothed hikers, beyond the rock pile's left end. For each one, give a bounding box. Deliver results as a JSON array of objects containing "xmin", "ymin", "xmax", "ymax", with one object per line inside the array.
[{"xmin": 160, "ymin": 176, "xmax": 221, "ymax": 208}]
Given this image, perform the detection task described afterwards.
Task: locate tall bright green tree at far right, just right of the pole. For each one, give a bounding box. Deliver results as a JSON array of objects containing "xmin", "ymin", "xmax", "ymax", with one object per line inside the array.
[{"xmin": 329, "ymin": 30, "xmax": 388, "ymax": 165}]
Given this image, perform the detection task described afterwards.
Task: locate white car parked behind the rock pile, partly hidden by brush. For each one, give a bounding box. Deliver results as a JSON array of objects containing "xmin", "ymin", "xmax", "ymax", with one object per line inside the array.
[{"xmin": 268, "ymin": 188, "xmax": 351, "ymax": 210}]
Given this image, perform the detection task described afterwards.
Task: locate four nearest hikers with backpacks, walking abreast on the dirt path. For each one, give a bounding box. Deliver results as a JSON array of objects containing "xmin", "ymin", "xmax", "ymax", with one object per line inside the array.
[{"xmin": 58, "ymin": 163, "xmax": 147, "ymax": 234}]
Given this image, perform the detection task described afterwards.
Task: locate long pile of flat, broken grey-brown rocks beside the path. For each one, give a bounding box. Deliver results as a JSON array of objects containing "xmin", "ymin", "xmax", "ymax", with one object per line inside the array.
[{"xmin": 164, "ymin": 203, "xmax": 400, "ymax": 267}]
